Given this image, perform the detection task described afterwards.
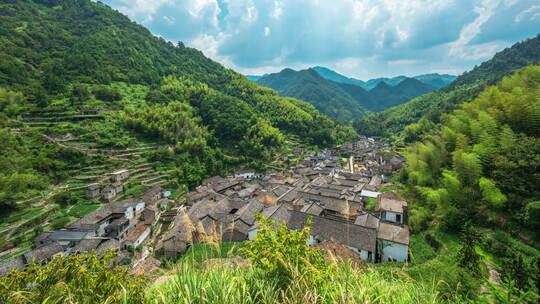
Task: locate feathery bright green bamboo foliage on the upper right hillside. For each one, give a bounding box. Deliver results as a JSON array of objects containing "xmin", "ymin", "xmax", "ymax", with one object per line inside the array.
[{"xmin": 401, "ymin": 66, "xmax": 540, "ymax": 235}]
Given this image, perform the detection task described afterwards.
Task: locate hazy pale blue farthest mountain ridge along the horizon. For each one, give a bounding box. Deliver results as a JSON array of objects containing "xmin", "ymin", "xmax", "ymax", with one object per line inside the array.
[{"xmin": 312, "ymin": 66, "xmax": 456, "ymax": 90}]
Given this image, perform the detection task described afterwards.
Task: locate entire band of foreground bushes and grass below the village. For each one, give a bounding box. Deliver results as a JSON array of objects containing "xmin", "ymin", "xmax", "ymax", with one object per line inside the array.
[{"xmin": 0, "ymin": 215, "xmax": 537, "ymax": 304}]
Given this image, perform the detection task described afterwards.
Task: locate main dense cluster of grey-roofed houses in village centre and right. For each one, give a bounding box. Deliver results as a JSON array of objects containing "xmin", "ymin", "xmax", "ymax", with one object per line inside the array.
[{"xmin": 157, "ymin": 139, "xmax": 409, "ymax": 262}]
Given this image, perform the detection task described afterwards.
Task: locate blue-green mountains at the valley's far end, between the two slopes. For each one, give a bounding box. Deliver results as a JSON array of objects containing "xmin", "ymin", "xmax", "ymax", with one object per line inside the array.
[{"xmin": 257, "ymin": 67, "xmax": 436, "ymax": 122}]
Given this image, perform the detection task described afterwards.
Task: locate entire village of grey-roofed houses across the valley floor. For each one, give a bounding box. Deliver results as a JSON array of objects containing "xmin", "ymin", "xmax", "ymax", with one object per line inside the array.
[{"xmin": 0, "ymin": 137, "xmax": 409, "ymax": 276}]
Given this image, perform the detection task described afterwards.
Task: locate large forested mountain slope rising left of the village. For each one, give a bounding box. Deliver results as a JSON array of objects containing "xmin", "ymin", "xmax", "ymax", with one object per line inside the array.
[{"xmin": 0, "ymin": 0, "xmax": 356, "ymax": 209}]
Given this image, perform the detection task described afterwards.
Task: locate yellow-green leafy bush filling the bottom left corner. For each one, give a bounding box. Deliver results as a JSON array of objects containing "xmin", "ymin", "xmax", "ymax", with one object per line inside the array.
[{"xmin": 0, "ymin": 252, "xmax": 145, "ymax": 304}]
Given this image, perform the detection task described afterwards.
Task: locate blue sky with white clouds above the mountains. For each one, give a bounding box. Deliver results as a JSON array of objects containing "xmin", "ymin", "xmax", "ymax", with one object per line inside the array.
[{"xmin": 102, "ymin": 0, "xmax": 540, "ymax": 80}]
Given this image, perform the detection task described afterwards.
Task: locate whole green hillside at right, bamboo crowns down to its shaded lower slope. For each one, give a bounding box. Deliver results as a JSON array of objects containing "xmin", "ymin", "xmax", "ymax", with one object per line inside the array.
[{"xmin": 401, "ymin": 66, "xmax": 540, "ymax": 294}]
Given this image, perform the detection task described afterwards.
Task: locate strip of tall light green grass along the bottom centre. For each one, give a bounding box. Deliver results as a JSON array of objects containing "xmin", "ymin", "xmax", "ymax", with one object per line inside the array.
[{"xmin": 148, "ymin": 261, "xmax": 448, "ymax": 304}]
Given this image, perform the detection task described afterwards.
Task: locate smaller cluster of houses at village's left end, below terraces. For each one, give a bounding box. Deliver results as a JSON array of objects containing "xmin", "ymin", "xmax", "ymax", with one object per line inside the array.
[{"xmin": 0, "ymin": 186, "xmax": 169, "ymax": 276}]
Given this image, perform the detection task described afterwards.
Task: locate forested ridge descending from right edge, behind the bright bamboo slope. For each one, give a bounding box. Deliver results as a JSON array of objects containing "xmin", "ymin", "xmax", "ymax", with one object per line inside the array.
[{"xmin": 354, "ymin": 35, "xmax": 540, "ymax": 135}]
